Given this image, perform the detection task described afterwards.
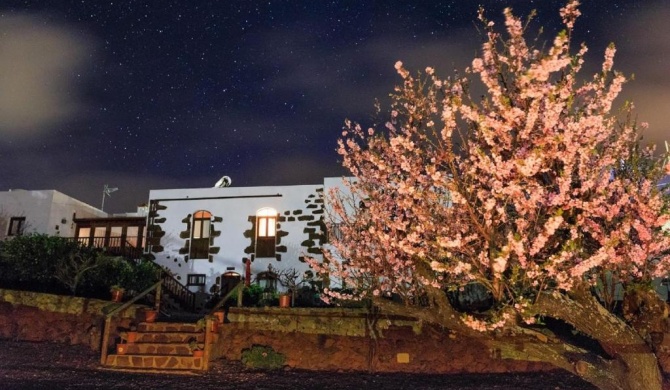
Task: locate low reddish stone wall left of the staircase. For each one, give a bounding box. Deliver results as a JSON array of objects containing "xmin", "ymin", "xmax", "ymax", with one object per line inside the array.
[{"xmin": 0, "ymin": 289, "xmax": 142, "ymax": 351}]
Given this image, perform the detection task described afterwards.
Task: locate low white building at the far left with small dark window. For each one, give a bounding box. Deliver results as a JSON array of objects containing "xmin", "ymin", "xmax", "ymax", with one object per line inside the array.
[{"xmin": 0, "ymin": 190, "xmax": 107, "ymax": 240}]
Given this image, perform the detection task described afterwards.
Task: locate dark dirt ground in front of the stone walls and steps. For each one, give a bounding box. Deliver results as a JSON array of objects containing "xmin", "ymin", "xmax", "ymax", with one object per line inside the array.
[{"xmin": 0, "ymin": 340, "xmax": 604, "ymax": 390}]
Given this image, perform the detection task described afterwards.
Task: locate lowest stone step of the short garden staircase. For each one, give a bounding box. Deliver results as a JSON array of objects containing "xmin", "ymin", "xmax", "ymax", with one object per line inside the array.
[{"xmin": 105, "ymin": 355, "xmax": 204, "ymax": 370}]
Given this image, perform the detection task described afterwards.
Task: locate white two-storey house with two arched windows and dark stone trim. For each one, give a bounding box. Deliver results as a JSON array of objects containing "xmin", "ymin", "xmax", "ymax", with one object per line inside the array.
[{"xmin": 145, "ymin": 179, "xmax": 341, "ymax": 292}]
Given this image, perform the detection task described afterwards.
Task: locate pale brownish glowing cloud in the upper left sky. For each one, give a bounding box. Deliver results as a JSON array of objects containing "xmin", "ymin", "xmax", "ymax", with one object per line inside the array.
[{"xmin": 0, "ymin": 16, "xmax": 90, "ymax": 138}]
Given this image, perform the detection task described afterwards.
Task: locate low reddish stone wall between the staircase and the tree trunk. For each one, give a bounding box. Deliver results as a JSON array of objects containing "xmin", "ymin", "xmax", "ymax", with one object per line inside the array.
[{"xmin": 213, "ymin": 308, "xmax": 555, "ymax": 373}]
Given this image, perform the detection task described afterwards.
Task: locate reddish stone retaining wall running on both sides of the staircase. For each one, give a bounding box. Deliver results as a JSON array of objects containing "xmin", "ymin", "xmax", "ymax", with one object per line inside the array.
[{"xmin": 5, "ymin": 289, "xmax": 670, "ymax": 373}]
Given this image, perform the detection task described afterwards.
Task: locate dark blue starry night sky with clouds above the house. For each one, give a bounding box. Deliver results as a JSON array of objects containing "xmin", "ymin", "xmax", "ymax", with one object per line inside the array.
[{"xmin": 0, "ymin": 0, "xmax": 670, "ymax": 212}]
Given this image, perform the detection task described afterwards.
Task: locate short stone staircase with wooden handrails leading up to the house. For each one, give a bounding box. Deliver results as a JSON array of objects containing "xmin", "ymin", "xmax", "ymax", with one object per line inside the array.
[{"xmin": 104, "ymin": 322, "xmax": 211, "ymax": 373}]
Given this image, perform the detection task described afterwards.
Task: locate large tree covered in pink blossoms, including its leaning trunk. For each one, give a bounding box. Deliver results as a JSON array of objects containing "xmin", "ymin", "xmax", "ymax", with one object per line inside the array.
[{"xmin": 315, "ymin": 0, "xmax": 670, "ymax": 389}]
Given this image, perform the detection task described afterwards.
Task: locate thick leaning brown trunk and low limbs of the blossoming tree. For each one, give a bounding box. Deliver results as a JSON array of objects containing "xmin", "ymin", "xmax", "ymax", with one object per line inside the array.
[{"xmin": 375, "ymin": 284, "xmax": 663, "ymax": 390}]
